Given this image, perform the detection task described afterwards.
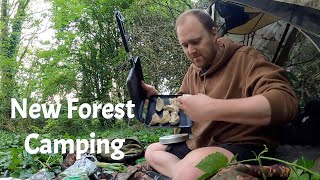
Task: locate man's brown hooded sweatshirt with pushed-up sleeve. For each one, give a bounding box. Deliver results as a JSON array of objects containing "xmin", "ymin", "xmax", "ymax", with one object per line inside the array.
[{"xmin": 179, "ymin": 38, "xmax": 298, "ymax": 149}]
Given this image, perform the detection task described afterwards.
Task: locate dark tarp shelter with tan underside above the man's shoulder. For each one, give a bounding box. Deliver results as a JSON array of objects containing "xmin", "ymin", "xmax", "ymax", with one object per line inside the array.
[{"xmin": 209, "ymin": 0, "xmax": 320, "ymax": 60}]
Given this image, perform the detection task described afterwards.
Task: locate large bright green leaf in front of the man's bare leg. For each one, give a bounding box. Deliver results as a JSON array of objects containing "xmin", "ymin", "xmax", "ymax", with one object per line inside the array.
[{"xmin": 196, "ymin": 152, "xmax": 228, "ymax": 175}]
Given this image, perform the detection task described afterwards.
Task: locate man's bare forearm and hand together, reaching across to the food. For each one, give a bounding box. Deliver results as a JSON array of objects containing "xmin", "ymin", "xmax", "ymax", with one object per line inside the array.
[{"xmin": 178, "ymin": 94, "xmax": 271, "ymax": 126}]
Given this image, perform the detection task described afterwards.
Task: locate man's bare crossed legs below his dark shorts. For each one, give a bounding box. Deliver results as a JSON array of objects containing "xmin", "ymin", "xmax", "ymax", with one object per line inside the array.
[{"xmin": 145, "ymin": 143, "xmax": 234, "ymax": 180}]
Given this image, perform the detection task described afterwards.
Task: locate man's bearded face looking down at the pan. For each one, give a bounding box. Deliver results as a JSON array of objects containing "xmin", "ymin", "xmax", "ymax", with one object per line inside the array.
[{"xmin": 177, "ymin": 15, "xmax": 217, "ymax": 68}]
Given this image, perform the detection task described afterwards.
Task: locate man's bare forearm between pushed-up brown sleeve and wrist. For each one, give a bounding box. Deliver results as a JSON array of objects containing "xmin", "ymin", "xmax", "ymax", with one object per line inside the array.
[{"xmin": 212, "ymin": 95, "xmax": 271, "ymax": 125}]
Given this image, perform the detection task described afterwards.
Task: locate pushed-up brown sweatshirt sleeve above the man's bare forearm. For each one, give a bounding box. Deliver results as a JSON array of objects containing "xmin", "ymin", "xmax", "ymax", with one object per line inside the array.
[{"xmin": 246, "ymin": 56, "xmax": 298, "ymax": 124}]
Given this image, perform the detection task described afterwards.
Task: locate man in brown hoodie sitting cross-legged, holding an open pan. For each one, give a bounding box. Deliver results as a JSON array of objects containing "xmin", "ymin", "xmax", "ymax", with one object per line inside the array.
[{"xmin": 142, "ymin": 10, "xmax": 298, "ymax": 180}]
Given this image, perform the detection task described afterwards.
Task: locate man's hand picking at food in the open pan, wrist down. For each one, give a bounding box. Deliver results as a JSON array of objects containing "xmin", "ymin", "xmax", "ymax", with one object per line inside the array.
[{"xmin": 177, "ymin": 94, "xmax": 214, "ymax": 121}]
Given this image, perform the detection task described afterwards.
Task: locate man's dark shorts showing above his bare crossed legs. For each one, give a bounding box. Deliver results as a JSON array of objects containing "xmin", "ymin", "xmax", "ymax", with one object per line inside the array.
[{"xmin": 165, "ymin": 142, "xmax": 273, "ymax": 165}]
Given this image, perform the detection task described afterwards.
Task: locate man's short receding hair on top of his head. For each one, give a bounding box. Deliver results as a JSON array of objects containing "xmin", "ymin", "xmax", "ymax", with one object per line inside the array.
[{"xmin": 176, "ymin": 9, "xmax": 216, "ymax": 32}]
